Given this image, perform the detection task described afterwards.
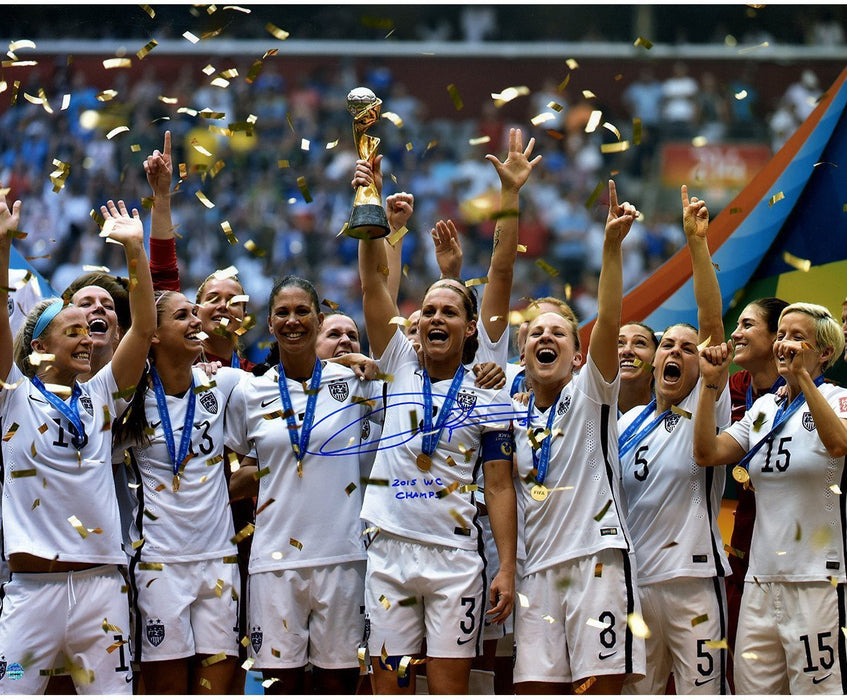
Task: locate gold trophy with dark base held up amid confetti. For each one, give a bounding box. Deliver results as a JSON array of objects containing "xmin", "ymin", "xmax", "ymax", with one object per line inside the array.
[{"xmin": 345, "ymin": 87, "xmax": 390, "ymax": 240}]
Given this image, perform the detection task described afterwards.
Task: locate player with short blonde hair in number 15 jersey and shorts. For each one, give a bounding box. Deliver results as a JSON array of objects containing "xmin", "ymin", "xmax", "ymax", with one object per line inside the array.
[{"xmin": 694, "ymin": 303, "xmax": 847, "ymax": 695}]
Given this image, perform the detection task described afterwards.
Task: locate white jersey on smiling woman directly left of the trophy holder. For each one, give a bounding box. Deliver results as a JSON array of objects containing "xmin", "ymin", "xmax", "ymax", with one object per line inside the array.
[{"xmin": 226, "ymin": 362, "xmax": 375, "ymax": 574}]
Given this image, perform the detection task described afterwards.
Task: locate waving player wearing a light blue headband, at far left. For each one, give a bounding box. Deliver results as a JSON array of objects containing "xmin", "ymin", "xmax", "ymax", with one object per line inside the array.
[{"xmin": 0, "ymin": 197, "xmax": 156, "ymax": 694}]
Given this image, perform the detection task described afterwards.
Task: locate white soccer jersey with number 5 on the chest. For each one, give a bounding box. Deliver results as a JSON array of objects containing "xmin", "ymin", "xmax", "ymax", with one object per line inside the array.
[{"xmin": 618, "ymin": 380, "xmax": 730, "ymax": 585}]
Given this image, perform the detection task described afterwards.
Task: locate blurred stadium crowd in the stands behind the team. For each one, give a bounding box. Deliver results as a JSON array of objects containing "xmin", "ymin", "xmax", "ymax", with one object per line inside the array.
[{"xmin": 0, "ymin": 5, "xmax": 844, "ymax": 356}]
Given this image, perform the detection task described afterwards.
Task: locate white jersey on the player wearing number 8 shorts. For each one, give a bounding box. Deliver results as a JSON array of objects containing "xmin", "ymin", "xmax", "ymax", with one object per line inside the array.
[{"xmin": 513, "ymin": 356, "xmax": 629, "ymax": 575}]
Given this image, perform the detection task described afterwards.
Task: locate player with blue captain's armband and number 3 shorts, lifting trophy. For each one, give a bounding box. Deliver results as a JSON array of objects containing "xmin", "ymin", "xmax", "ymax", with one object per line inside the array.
[{"xmin": 359, "ymin": 129, "xmax": 538, "ymax": 693}]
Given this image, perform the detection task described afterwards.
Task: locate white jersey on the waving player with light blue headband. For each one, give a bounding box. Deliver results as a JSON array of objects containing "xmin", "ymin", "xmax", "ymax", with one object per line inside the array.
[{"xmin": 0, "ymin": 363, "xmax": 126, "ymax": 564}]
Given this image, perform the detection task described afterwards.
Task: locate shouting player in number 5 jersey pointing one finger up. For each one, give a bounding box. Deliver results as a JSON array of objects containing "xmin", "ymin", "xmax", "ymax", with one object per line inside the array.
[{"xmin": 618, "ymin": 185, "xmax": 729, "ymax": 695}]
